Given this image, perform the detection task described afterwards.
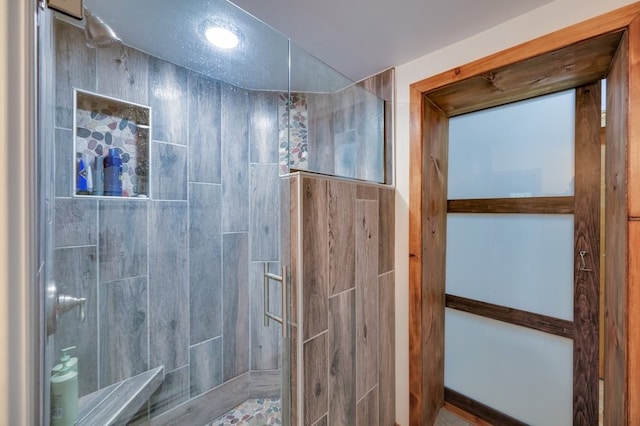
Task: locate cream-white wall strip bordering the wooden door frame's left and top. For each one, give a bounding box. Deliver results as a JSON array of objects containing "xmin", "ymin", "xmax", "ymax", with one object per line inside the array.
[{"xmin": 395, "ymin": 0, "xmax": 634, "ymax": 426}]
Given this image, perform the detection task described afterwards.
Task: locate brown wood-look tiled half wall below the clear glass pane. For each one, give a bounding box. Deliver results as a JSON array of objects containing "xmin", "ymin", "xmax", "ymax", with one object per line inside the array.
[{"xmin": 286, "ymin": 173, "xmax": 395, "ymax": 426}]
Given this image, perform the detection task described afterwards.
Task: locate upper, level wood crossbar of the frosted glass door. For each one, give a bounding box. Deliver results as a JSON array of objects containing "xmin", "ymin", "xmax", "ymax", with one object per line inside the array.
[{"xmin": 447, "ymin": 196, "xmax": 574, "ymax": 214}]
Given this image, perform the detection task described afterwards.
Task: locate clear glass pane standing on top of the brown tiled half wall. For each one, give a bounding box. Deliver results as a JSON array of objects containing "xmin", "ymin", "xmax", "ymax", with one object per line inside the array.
[{"xmin": 290, "ymin": 43, "xmax": 385, "ymax": 182}]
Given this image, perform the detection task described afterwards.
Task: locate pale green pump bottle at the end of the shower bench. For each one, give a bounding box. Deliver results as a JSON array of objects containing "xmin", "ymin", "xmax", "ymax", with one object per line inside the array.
[{"xmin": 51, "ymin": 346, "xmax": 78, "ymax": 426}]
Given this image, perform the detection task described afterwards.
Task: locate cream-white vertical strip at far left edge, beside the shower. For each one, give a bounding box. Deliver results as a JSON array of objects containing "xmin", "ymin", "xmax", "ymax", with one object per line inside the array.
[{"xmin": 0, "ymin": 0, "xmax": 39, "ymax": 425}]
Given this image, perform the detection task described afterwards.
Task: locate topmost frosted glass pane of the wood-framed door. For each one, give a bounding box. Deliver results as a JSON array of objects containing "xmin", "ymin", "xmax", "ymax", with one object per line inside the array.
[{"xmin": 448, "ymin": 90, "xmax": 575, "ymax": 200}]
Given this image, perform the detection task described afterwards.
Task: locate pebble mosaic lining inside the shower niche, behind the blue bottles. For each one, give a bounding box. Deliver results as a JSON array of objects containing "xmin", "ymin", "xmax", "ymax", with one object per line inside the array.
[{"xmin": 75, "ymin": 92, "xmax": 149, "ymax": 197}]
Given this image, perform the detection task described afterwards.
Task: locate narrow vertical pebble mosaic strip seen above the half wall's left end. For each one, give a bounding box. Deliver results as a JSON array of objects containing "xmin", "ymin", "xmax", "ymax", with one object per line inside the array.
[{"xmin": 278, "ymin": 93, "xmax": 309, "ymax": 174}]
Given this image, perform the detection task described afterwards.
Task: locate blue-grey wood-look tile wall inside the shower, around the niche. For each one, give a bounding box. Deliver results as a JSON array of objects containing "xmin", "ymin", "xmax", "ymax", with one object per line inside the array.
[{"xmin": 54, "ymin": 22, "xmax": 280, "ymax": 424}]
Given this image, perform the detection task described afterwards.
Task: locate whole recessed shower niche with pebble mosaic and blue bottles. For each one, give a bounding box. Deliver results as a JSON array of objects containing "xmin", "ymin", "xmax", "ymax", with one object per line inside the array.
[{"xmin": 72, "ymin": 89, "xmax": 151, "ymax": 198}]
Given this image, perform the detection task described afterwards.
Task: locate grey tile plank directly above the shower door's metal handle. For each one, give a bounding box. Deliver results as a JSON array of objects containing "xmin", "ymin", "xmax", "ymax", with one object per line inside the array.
[{"xmin": 249, "ymin": 164, "xmax": 280, "ymax": 261}]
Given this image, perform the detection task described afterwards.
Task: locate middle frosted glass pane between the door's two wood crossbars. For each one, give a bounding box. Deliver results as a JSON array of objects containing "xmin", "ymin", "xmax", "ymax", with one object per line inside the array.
[{"xmin": 446, "ymin": 213, "xmax": 573, "ymax": 321}]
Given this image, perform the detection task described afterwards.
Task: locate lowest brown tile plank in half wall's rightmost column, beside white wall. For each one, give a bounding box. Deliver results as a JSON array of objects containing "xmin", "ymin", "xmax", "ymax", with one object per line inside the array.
[{"xmin": 378, "ymin": 271, "xmax": 396, "ymax": 426}]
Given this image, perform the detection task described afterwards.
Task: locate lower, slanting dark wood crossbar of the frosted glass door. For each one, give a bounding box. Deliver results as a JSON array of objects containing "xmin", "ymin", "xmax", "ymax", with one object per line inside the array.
[{"xmin": 446, "ymin": 294, "xmax": 574, "ymax": 339}]
